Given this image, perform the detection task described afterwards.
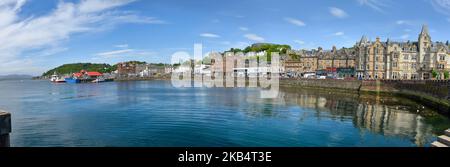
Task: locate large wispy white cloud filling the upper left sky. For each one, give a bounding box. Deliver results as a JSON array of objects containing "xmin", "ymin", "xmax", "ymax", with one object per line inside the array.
[{"xmin": 0, "ymin": 0, "xmax": 164, "ymax": 73}]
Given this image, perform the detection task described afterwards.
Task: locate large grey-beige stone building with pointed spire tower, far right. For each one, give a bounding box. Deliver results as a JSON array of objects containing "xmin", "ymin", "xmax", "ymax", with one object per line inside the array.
[{"xmin": 355, "ymin": 25, "xmax": 450, "ymax": 80}]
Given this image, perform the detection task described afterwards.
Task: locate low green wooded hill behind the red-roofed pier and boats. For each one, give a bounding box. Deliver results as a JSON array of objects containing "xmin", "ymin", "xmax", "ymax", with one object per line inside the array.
[{"xmin": 42, "ymin": 63, "xmax": 116, "ymax": 76}]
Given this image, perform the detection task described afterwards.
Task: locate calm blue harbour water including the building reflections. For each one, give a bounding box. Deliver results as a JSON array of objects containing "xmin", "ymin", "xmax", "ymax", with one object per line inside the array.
[{"xmin": 0, "ymin": 80, "xmax": 450, "ymax": 146}]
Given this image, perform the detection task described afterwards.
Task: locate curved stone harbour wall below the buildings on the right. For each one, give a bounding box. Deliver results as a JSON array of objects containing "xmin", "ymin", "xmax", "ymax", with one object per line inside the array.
[{"xmin": 280, "ymin": 79, "xmax": 450, "ymax": 117}]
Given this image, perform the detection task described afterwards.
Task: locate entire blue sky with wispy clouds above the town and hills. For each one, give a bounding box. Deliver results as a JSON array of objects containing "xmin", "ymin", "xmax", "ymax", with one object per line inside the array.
[{"xmin": 0, "ymin": 0, "xmax": 450, "ymax": 75}]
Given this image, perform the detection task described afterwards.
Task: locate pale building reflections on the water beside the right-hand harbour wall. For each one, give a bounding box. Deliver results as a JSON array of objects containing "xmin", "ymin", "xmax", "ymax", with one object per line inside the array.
[{"xmin": 274, "ymin": 91, "xmax": 432, "ymax": 146}]
